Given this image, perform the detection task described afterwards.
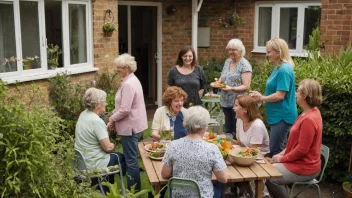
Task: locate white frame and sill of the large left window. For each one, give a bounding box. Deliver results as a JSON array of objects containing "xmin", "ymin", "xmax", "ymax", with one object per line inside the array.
[{"xmin": 0, "ymin": 0, "xmax": 98, "ymax": 84}]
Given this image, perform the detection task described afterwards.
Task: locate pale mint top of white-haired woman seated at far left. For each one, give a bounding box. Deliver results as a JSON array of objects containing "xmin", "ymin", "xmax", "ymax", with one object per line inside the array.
[{"xmin": 75, "ymin": 109, "xmax": 110, "ymax": 169}]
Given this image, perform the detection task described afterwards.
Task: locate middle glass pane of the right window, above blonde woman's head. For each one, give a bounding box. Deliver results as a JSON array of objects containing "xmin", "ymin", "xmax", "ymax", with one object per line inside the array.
[{"xmin": 280, "ymin": 8, "xmax": 298, "ymax": 49}]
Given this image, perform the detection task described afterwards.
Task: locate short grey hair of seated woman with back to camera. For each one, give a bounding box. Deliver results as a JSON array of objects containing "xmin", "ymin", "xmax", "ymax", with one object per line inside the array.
[{"xmin": 183, "ymin": 106, "xmax": 210, "ymax": 134}]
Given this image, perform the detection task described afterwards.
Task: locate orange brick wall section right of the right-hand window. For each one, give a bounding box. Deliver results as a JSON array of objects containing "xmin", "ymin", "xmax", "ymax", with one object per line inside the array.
[{"xmin": 320, "ymin": 0, "xmax": 352, "ymax": 53}]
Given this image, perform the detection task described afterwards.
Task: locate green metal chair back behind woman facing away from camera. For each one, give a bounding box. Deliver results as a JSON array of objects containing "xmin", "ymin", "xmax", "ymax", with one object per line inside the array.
[{"xmin": 168, "ymin": 177, "xmax": 201, "ymax": 198}]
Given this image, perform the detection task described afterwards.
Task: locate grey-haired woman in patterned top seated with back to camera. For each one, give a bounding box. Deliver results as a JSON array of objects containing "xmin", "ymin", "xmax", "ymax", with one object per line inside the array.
[{"xmin": 161, "ymin": 106, "xmax": 227, "ymax": 197}]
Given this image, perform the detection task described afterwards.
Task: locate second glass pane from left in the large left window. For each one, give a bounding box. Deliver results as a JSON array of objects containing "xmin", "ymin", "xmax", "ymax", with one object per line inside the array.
[{"xmin": 20, "ymin": 1, "xmax": 41, "ymax": 70}]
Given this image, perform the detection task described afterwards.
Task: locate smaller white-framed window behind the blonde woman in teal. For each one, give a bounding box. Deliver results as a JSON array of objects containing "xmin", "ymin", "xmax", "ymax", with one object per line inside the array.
[{"xmin": 253, "ymin": 2, "xmax": 321, "ymax": 56}]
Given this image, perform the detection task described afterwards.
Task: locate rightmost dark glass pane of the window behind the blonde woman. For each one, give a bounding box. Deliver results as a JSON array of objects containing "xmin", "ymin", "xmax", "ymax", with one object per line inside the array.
[{"xmin": 303, "ymin": 6, "xmax": 321, "ymax": 46}]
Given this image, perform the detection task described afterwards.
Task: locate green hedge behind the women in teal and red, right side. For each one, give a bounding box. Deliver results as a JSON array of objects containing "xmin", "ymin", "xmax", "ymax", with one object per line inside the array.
[{"xmin": 252, "ymin": 47, "xmax": 352, "ymax": 181}]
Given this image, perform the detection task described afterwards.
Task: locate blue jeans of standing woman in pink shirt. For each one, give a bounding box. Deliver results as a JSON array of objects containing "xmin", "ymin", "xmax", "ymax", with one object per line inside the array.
[{"xmin": 121, "ymin": 131, "xmax": 143, "ymax": 191}]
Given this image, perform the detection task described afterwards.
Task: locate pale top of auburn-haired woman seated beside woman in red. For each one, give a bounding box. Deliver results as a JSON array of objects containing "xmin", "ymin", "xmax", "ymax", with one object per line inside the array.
[{"xmin": 236, "ymin": 119, "xmax": 270, "ymax": 155}]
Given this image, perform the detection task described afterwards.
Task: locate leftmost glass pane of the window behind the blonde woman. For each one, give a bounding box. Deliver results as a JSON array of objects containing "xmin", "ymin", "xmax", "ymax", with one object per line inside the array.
[{"xmin": 258, "ymin": 7, "xmax": 272, "ymax": 46}]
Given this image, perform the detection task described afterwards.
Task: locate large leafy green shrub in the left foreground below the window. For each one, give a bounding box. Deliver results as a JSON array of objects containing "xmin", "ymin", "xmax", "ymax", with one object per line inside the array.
[{"xmin": 0, "ymin": 80, "xmax": 102, "ymax": 198}]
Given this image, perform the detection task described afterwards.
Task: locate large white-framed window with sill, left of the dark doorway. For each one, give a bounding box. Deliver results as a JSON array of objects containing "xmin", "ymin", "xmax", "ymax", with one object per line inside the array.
[{"xmin": 0, "ymin": 0, "xmax": 97, "ymax": 83}]
